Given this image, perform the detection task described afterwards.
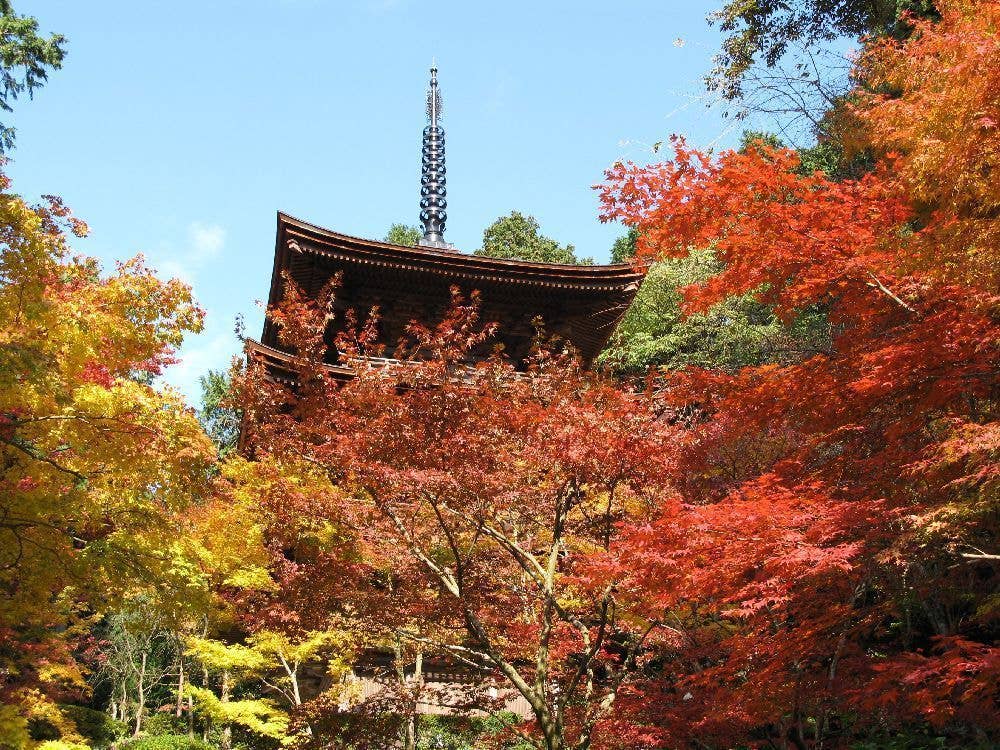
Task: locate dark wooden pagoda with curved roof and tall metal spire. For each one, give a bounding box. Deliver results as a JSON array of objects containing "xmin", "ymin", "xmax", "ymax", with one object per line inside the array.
[{"xmin": 249, "ymin": 67, "xmax": 643, "ymax": 379}]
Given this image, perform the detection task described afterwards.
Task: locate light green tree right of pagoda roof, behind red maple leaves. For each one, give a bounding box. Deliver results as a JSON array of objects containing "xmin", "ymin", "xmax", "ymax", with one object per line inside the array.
[{"xmin": 599, "ymin": 250, "xmax": 829, "ymax": 376}]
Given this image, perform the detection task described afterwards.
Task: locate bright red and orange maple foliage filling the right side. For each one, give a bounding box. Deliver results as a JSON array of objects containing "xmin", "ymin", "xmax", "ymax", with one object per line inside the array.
[{"xmin": 601, "ymin": 3, "xmax": 1000, "ymax": 747}]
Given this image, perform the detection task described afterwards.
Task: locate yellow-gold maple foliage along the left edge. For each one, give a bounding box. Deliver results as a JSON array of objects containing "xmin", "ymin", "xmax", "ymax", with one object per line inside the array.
[{"xmin": 0, "ymin": 178, "xmax": 221, "ymax": 747}]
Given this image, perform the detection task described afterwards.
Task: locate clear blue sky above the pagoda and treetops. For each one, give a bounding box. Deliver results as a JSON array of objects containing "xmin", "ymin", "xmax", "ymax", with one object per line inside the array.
[{"xmin": 5, "ymin": 0, "xmax": 756, "ymax": 404}]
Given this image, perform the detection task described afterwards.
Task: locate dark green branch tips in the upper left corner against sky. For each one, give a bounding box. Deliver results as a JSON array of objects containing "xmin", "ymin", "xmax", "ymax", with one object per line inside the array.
[{"xmin": 0, "ymin": 0, "xmax": 66, "ymax": 154}]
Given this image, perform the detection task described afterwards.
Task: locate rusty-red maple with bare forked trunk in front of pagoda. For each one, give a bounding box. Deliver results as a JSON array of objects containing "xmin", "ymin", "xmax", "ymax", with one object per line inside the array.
[{"xmin": 239, "ymin": 282, "xmax": 671, "ymax": 748}]
